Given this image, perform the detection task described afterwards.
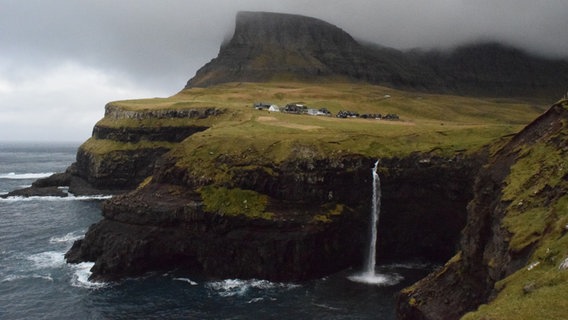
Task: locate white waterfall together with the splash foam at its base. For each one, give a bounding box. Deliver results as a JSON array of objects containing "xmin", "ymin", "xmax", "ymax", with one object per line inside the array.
[{"xmin": 349, "ymin": 160, "xmax": 402, "ymax": 286}]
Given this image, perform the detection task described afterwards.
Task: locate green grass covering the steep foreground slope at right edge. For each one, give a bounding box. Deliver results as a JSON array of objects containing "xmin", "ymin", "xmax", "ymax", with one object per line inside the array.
[{"xmin": 463, "ymin": 103, "xmax": 568, "ymax": 320}]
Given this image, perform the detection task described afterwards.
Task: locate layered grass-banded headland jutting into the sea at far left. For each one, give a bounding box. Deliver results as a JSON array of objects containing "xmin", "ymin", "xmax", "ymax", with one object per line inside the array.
[{"xmin": 5, "ymin": 102, "xmax": 223, "ymax": 197}]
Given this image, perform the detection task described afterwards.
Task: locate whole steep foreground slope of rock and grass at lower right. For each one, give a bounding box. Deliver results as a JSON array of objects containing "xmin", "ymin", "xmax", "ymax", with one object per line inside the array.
[{"xmin": 399, "ymin": 100, "xmax": 568, "ymax": 319}]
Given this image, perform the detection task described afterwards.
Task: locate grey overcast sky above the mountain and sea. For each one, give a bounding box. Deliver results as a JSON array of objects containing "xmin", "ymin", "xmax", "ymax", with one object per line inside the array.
[{"xmin": 0, "ymin": 0, "xmax": 568, "ymax": 142}]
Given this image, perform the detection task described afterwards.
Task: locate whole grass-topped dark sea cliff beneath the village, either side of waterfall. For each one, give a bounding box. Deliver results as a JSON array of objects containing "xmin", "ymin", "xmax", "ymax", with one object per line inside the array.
[{"xmin": 58, "ymin": 72, "xmax": 535, "ymax": 281}]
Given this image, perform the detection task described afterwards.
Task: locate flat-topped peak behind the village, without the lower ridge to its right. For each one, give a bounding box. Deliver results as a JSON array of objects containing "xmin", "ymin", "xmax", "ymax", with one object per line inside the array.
[{"xmin": 186, "ymin": 12, "xmax": 432, "ymax": 88}]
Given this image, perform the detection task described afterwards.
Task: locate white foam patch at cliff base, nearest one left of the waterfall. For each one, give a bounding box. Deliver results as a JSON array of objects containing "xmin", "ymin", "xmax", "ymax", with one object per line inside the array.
[{"xmin": 205, "ymin": 279, "xmax": 299, "ymax": 297}]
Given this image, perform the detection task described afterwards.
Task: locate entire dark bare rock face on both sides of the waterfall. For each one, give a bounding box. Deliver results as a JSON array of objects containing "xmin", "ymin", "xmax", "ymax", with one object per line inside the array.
[{"xmin": 66, "ymin": 155, "xmax": 478, "ymax": 281}]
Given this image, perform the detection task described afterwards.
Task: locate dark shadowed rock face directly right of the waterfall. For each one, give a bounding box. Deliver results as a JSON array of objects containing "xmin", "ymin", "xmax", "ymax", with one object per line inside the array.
[{"xmin": 378, "ymin": 154, "xmax": 483, "ymax": 261}]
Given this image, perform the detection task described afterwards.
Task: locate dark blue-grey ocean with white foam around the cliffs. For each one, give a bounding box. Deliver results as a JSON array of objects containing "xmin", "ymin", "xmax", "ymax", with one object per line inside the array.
[{"xmin": 0, "ymin": 143, "xmax": 433, "ymax": 320}]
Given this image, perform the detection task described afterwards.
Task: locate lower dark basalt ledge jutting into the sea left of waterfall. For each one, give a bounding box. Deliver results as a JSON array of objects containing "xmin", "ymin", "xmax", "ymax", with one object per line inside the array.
[{"xmin": 66, "ymin": 185, "xmax": 364, "ymax": 281}]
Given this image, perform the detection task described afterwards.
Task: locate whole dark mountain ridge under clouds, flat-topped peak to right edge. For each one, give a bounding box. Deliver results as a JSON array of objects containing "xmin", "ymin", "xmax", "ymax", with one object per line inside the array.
[{"xmin": 186, "ymin": 12, "xmax": 568, "ymax": 97}]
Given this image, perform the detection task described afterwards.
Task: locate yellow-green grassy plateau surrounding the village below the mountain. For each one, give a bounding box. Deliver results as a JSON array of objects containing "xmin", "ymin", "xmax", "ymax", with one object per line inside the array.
[{"xmin": 105, "ymin": 82, "xmax": 544, "ymax": 161}]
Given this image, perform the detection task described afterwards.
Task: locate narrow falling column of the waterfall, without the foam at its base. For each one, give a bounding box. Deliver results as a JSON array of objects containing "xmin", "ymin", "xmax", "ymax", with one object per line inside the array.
[{"xmin": 363, "ymin": 160, "xmax": 381, "ymax": 276}]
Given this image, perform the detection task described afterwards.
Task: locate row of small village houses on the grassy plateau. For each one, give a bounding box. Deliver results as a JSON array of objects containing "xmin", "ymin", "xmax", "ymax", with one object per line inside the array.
[{"xmin": 253, "ymin": 102, "xmax": 400, "ymax": 120}]
